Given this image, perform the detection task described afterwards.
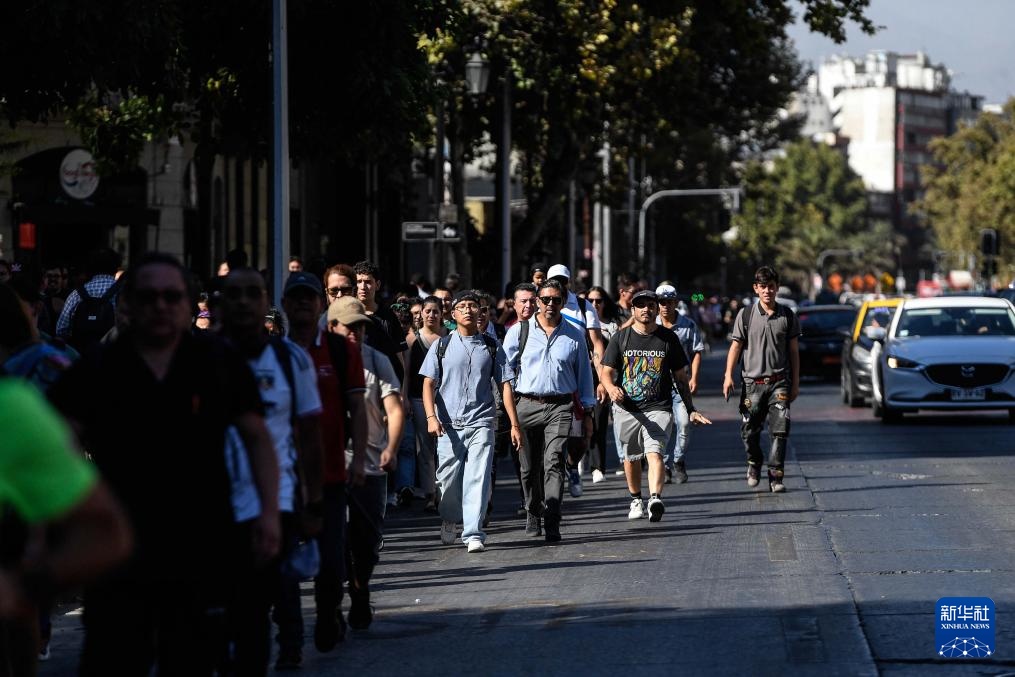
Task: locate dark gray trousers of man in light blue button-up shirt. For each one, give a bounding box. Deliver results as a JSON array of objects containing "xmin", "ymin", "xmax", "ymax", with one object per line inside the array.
[{"xmin": 518, "ymin": 398, "xmax": 573, "ymax": 517}]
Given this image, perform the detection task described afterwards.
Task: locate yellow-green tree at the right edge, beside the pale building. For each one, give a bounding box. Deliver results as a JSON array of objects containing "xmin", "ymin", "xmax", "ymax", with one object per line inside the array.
[{"xmin": 919, "ymin": 99, "xmax": 1015, "ymax": 280}]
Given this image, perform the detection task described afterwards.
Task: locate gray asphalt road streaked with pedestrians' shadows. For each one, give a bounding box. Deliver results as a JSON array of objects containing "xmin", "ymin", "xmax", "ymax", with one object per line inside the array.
[{"xmin": 42, "ymin": 345, "xmax": 1015, "ymax": 677}]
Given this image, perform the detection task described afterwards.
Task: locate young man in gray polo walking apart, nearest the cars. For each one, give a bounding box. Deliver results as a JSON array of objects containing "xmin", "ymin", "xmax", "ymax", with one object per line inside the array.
[{"xmin": 723, "ymin": 266, "xmax": 800, "ymax": 493}]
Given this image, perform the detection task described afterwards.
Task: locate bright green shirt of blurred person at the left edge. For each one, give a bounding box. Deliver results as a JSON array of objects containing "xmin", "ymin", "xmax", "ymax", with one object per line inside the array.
[{"xmin": 0, "ymin": 379, "xmax": 97, "ymax": 524}]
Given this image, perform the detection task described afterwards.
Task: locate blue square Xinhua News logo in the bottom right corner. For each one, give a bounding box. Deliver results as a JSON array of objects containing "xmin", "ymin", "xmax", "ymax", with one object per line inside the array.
[{"xmin": 934, "ymin": 597, "xmax": 998, "ymax": 659}]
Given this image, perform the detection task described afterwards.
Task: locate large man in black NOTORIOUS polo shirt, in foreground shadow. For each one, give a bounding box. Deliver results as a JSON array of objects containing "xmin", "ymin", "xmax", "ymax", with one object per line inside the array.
[{"xmin": 49, "ymin": 254, "xmax": 279, "ymax": 675}]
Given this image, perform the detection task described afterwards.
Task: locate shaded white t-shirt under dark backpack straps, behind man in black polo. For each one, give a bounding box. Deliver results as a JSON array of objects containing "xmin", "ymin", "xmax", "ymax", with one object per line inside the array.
[{"xmin": 225, "ymin": 338, "xmax": 322, "ymax": 522}]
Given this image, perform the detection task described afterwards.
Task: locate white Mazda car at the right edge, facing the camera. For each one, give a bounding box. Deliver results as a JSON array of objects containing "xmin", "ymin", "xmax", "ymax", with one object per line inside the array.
[{"xmin": 871, "ymin": 296, "xmax": 1015, "ymax": 422}]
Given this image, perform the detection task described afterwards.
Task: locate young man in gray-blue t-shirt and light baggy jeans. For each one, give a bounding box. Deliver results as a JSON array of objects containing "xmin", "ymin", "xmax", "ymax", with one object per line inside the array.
[{"xmin": 419, "ymin": 290, "xmax": 522, "ymax": 552}]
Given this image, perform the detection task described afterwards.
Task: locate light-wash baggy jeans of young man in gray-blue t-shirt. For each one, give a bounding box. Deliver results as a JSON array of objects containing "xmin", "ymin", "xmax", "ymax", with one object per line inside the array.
[{"xmin": 437, "ymin": 425, "xmax": 493, "ymax": 543}]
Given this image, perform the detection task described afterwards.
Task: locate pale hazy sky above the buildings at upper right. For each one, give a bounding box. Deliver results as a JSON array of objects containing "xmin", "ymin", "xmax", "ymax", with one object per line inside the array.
[{"xmin": 789, "ymin": 0, "xmax": 1015, "ymax": 104}]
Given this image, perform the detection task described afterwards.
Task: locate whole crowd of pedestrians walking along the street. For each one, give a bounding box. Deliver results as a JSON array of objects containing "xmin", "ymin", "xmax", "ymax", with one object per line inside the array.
[{"xmin": 0, "ymin": 251, "xmax": 799, "ymax": 675}]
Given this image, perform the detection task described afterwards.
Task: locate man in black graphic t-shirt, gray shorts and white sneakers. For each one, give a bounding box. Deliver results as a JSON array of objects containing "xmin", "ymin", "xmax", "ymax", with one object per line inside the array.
[{"xmin": 603, "ymin": 290, "xmax": 712, "ymax": 522}]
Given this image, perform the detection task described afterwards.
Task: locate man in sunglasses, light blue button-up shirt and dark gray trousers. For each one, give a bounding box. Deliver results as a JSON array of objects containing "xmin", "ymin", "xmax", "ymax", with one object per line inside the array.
[{"xmin": 504, "ymin": 280, "xmax": 596, "ymax": 542}]
